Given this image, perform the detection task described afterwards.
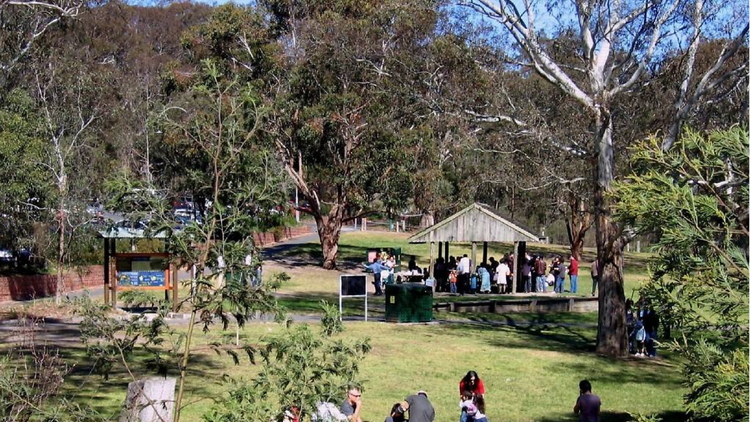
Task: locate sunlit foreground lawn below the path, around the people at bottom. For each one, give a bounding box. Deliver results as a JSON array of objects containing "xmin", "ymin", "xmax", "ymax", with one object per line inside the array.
[{"xmin": 55, "ymin": 322, "xmax": 685, "ymax": 422}]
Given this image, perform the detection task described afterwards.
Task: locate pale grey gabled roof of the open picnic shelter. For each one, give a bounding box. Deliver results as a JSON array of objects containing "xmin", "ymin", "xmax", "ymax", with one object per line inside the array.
[{"xmin": 409, "ymin": 203, "xmax": 539, "ymax": 243}]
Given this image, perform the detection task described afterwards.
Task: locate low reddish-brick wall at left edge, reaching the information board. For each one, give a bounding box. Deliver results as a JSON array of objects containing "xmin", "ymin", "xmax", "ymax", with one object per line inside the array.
[{"xmin": 0, "ymin": 265, "xmax": 104, "ymax": 302}]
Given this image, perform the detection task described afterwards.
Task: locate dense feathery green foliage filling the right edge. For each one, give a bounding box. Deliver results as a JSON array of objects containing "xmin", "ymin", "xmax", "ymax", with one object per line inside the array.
[{"xmin": 612, "ymin": 127, "xmax": 749, "ymax": 421}]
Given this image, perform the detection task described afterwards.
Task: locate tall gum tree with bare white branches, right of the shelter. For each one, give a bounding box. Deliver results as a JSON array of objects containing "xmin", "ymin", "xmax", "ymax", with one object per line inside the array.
[{"xmin": 468, "ymin": 0, "xmax": 747, "ymax": 356}]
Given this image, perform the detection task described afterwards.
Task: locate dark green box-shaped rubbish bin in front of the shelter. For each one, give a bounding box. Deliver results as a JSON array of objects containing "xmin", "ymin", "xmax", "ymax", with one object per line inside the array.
[{"xmin": 385, "ymin": 283, "xmax": 432, "ymax": 322}]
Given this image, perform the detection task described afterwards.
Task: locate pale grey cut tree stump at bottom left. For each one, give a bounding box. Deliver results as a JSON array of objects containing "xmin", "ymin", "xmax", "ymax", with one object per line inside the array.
[{"xmin": 120, "ymin": 378, "xmax": 176, "ymax": 422}]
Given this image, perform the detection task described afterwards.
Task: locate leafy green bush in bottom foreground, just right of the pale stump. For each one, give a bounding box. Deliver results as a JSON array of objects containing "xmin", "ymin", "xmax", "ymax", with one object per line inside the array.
[{"xmin": 203, "ymin": 302, "xmax": 371, "ymax": 422}]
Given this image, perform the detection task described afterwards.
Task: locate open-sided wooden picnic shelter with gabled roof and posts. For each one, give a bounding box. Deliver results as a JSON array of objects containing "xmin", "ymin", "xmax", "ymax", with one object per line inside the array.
[{"xmin": 409, "ymin": 203, "xmax": 539, "ymax": 292}]
